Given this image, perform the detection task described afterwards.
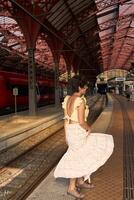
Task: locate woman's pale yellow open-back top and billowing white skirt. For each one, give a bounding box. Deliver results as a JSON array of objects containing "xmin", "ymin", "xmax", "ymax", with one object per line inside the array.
[{"xmin": 54, "ymin": 96, "xmax": 114, "ymax": 182}]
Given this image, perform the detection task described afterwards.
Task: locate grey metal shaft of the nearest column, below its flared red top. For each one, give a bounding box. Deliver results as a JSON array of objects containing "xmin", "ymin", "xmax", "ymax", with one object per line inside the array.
[{"xmin": 28, "ymin": 48, "xmax": 37, "ymax": 115}]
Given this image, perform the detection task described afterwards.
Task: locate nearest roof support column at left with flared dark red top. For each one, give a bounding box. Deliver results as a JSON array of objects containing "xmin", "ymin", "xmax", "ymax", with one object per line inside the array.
[{"xmin": 11, "ymin": 0, "xmax": 45, "ymax": 115}]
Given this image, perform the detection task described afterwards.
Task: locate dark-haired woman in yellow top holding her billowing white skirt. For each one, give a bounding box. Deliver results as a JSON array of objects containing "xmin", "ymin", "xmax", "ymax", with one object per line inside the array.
[{"xmin": 54, "ymin": 76, "xmax": 114, "ymax": 199}]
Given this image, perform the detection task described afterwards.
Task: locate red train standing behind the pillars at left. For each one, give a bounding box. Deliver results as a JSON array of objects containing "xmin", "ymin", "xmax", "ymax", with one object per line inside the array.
[{"xmin": 0, "ymin": 71, "xmax": 65, "ymax": 113}]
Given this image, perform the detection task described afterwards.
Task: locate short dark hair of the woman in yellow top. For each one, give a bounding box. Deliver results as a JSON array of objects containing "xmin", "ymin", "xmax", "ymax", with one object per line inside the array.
[{"xmin": 67, "ymin": 75, "xmax": 88, "ymax": 95}]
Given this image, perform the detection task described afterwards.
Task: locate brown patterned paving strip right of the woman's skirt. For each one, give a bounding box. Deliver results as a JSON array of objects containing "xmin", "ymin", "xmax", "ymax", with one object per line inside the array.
[{"xmin": 82, "ymin": 97, "xmax": 123, "ymax": 200}]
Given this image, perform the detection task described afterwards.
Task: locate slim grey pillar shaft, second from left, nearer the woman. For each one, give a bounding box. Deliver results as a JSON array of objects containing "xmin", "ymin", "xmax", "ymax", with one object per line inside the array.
[{"xmin": 55, "ymin": 62, "xmax": 60, "ymax": 107}]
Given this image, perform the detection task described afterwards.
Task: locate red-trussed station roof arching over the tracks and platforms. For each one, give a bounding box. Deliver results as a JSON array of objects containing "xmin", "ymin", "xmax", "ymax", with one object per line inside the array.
[{"xmin": 0, "ymin": 0, "xmax": 134, "ymax": 79}]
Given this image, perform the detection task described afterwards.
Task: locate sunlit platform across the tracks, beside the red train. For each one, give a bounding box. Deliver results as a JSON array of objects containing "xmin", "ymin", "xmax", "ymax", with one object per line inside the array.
[{"xmin": 0, "ymin": 106, "xmax": 63, "ymax": 140}]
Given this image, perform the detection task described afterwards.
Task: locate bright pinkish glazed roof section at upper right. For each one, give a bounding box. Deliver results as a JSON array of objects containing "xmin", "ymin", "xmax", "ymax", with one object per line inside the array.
[{"xmin": 96, "ymin": 0, "xmax": 134, "ymax": 70}]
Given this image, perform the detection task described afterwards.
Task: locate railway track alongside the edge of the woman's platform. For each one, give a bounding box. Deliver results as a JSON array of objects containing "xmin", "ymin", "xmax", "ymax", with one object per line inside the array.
[{"xmin": 0, "ymin": 94, "xmax": 105, "ymax": 200}]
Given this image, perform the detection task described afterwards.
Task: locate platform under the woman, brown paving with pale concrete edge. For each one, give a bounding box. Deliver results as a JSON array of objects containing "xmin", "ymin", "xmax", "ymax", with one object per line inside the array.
[{"xmin": 27, "ymin": 96, "xmax": 118, "ymax": 200}]
